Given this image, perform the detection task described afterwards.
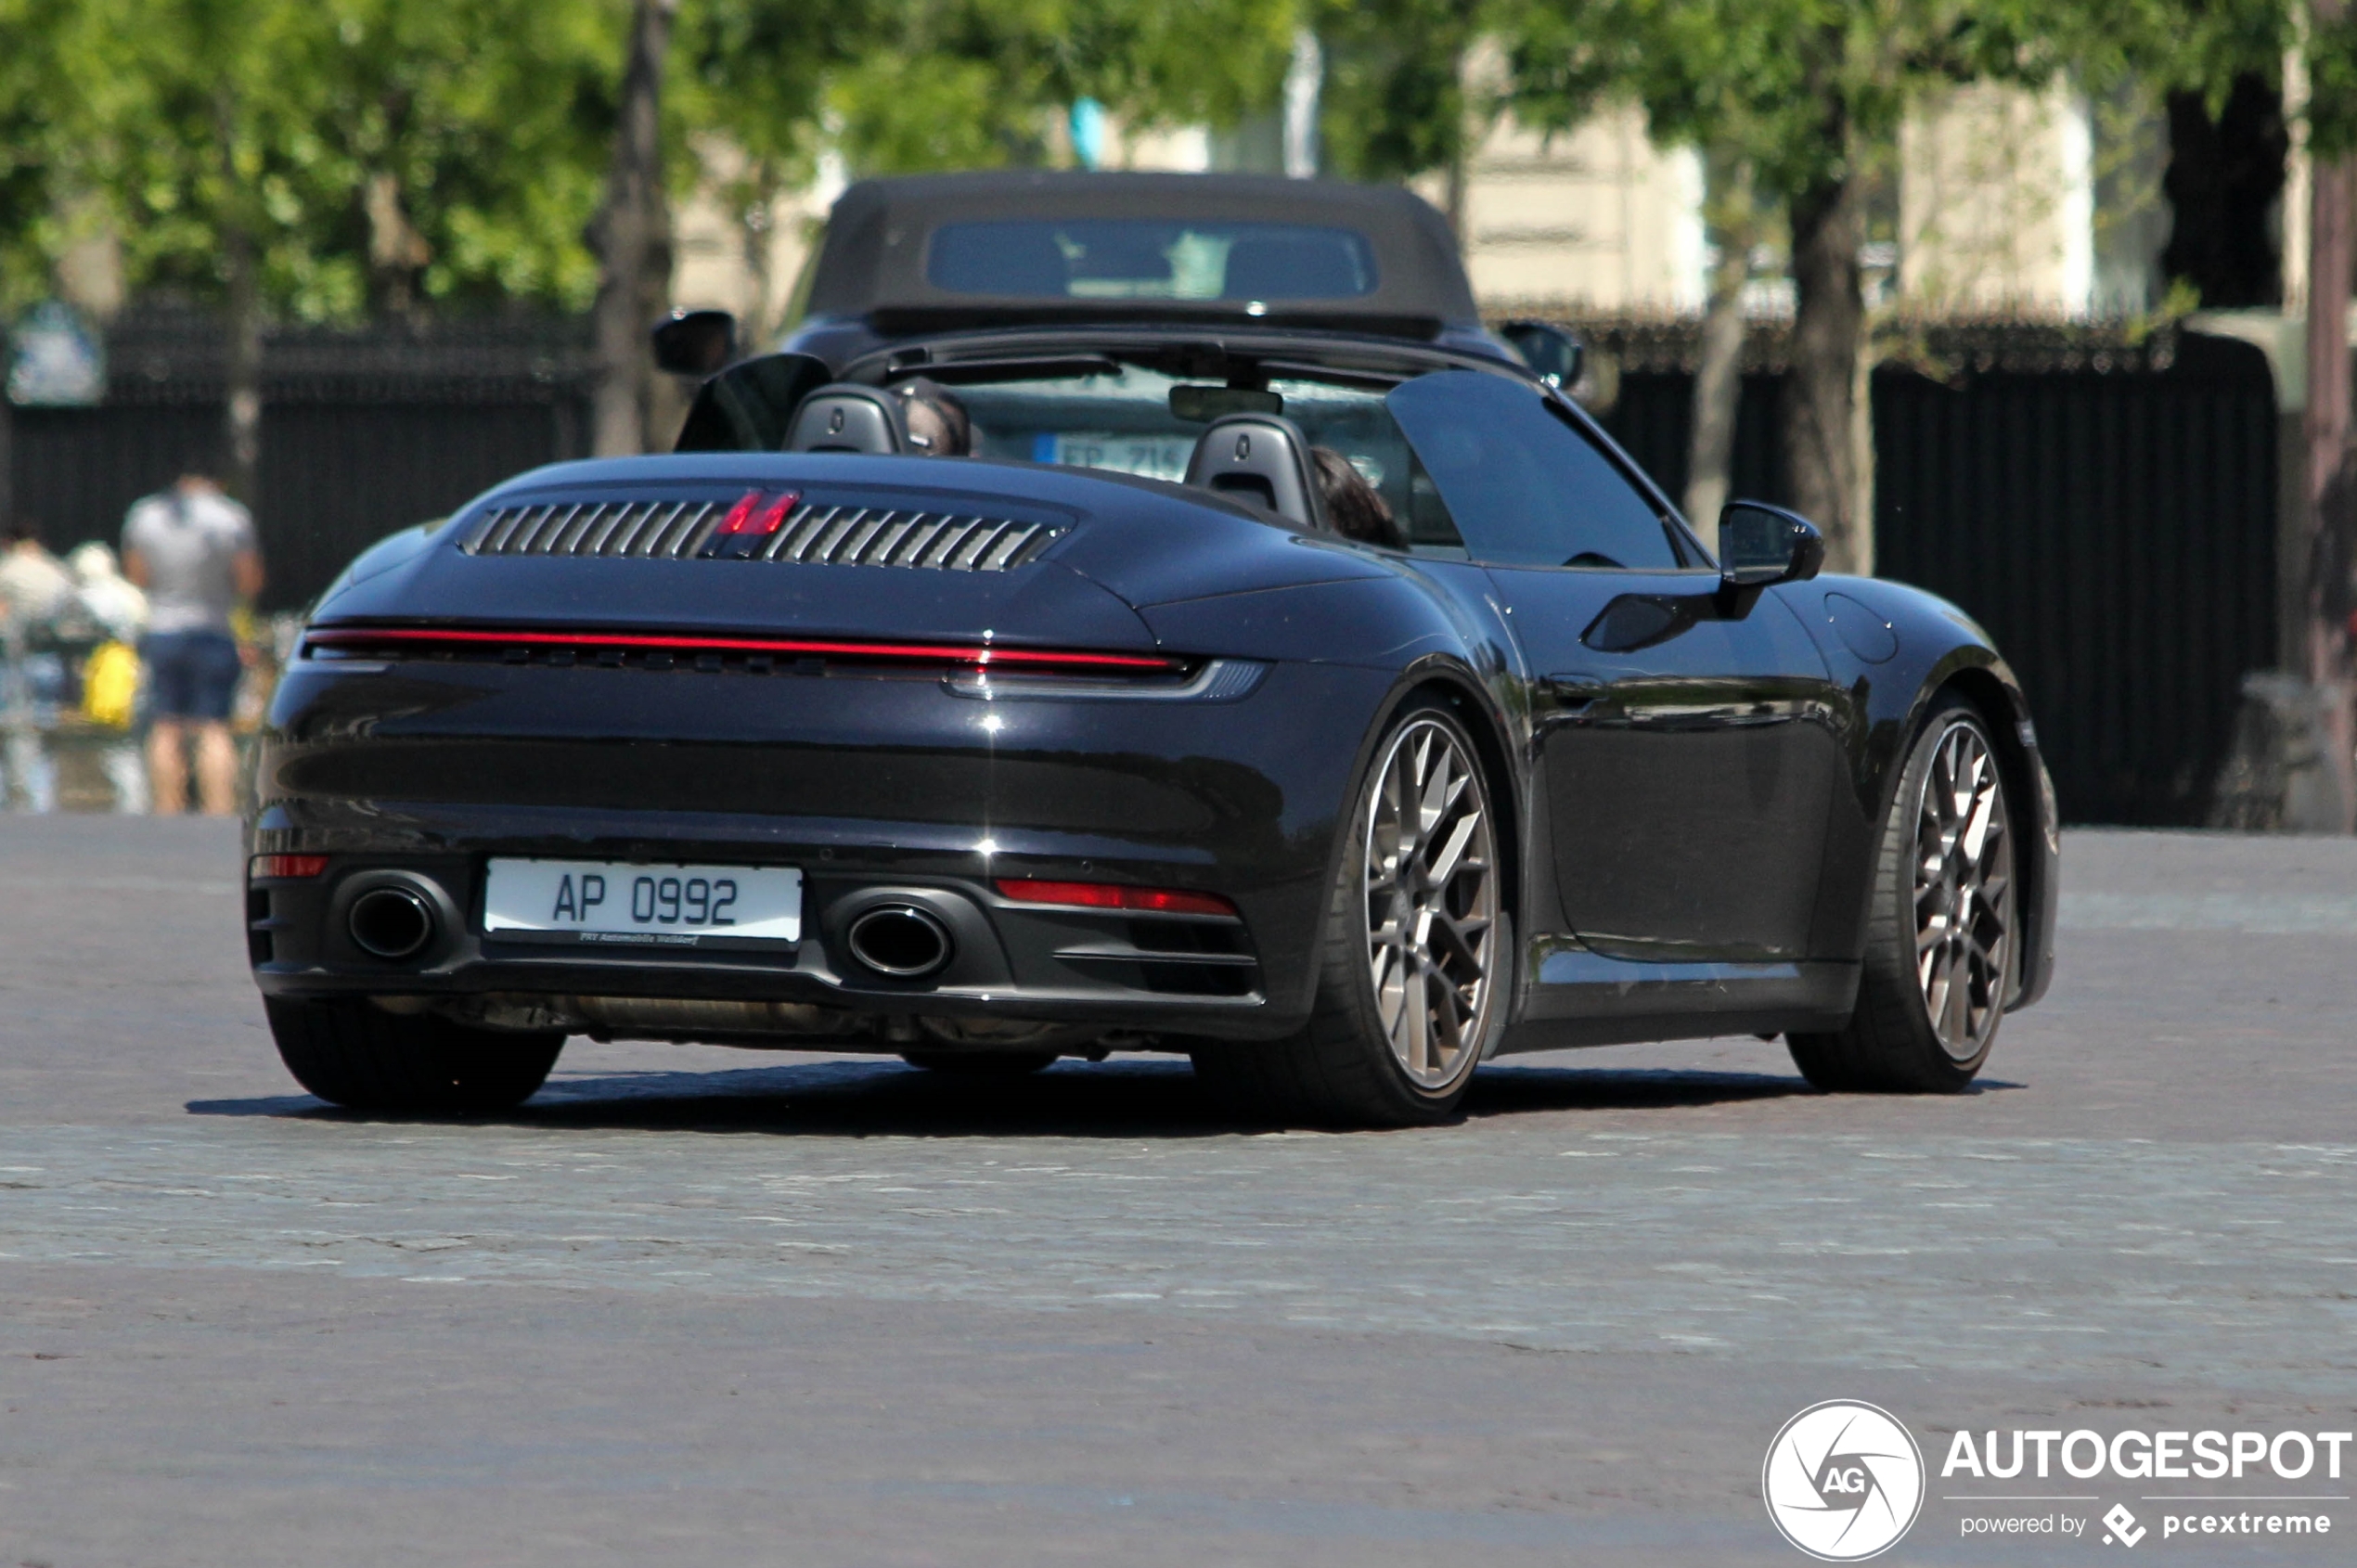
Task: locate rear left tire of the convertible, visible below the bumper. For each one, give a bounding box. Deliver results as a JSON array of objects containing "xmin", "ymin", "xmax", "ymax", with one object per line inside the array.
[{"xmin": 262, "ymin": 997, "xmax": 566, "ymax": 1115}]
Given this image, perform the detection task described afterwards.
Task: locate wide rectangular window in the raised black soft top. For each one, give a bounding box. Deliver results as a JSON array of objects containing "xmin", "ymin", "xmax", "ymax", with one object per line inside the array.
[{"xmin": 924, "ymin": 217, "xmax": 1374, "ymax": 302}]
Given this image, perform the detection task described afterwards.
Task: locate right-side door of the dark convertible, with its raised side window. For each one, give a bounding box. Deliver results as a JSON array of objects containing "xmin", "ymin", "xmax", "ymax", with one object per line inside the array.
[{"xmin": 1391, "ymin": 373, "xmax": 1841, "ymax": 962}]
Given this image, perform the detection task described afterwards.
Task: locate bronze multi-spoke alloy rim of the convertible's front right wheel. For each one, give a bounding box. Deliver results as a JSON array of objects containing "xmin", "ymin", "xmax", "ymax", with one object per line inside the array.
[{"xmin": 1913, "ymin": 719, "xmax": 2013, "ymax": 1061}]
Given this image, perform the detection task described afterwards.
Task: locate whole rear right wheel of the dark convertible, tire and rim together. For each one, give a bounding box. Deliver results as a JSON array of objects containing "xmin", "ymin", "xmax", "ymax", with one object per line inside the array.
[{"xmin": 1192, "ymin": 702, "xmax": 1513, "ymax": 1127}]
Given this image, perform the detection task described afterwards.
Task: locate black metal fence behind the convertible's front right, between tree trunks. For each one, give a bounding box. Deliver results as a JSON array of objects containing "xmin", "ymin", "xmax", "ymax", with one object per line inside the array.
[{"xmin": 1605, "ymin": 335, "xmax": 2279, "ymax": 825}]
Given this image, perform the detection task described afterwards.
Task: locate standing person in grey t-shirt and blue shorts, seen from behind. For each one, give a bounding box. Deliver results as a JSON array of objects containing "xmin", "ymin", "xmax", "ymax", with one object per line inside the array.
[{"xmin": 122, "ymin": 474, "xmax": 262, "ymax": 816}]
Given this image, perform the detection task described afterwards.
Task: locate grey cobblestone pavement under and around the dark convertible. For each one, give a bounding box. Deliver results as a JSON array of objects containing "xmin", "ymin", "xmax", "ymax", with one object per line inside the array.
[{"xmin": 0, "ymin": 818, "xmax": 2357, "ymax": 1568}]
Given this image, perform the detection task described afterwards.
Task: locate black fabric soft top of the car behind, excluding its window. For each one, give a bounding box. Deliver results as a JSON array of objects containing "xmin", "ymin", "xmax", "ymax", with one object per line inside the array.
[{"xmin": 808, "ymin": 170, "xmax": 1480, "ymax": 337}]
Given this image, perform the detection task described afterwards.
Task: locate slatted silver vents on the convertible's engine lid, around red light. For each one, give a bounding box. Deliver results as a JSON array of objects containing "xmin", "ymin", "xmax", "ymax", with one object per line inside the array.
[{"xmin": 459, "ymin": 500, "xmax": 1068, "ymax": 571}]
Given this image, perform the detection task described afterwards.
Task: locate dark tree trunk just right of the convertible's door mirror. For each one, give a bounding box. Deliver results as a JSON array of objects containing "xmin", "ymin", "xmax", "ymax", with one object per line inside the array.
[{"xmin": 1782, "ymin": 149, "xmax": 1872, "ymax": 571}]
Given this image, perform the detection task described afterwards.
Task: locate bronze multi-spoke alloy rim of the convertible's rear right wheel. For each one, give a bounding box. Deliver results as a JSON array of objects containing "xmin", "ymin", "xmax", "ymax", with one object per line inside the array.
[{"xmin": 1365, "ymin": 717, "xmax": 1497, "ymax": 1089}]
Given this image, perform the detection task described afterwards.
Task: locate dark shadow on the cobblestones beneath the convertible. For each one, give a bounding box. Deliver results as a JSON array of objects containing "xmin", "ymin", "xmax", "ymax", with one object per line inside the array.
[{"xmin": 187, "ymin": 1057, "xmax": 1866, "ymax": 1138}]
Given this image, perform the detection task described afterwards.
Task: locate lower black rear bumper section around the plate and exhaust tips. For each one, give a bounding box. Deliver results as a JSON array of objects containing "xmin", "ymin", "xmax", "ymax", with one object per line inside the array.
[{"xmin": 245, "ymin": 846, "xmax": 1299, "ymax": 1042}]
